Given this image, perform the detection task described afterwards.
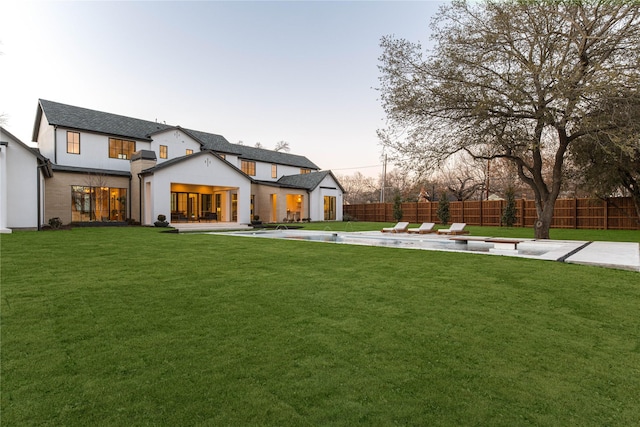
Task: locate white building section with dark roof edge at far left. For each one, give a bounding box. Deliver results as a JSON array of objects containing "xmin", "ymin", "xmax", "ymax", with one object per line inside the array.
[{"xmin": 0, "ymin": 127, "xmax": 52, "ymax": 233}]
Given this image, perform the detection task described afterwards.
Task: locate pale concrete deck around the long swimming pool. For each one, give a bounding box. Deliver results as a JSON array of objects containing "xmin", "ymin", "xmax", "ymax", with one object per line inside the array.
[{"xmin": 172, "ymin": 223, "xmax": 640, "ymax": 272}]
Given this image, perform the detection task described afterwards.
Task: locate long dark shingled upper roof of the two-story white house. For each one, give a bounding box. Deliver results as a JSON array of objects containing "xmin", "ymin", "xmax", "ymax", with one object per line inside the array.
[{"xmin": 33, "ymin": 99, "xmax": 320, "ymax": 170}]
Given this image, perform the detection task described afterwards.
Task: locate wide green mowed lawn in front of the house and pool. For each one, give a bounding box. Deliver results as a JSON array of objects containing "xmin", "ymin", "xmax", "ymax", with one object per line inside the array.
[{"xmin": 0, "ymin": 223, "xmax": 640, "ymax": 426}]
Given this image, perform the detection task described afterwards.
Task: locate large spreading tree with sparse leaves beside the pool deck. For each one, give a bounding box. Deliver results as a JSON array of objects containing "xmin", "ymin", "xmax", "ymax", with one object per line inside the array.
[{"xmin": 379, "ymin": 0, "xmax": 640, "ymax": 238}]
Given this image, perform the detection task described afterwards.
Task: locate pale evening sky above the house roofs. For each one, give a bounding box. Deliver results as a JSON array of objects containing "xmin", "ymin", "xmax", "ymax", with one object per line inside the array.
[{"xmin": 0, "ymin": 0, "xmax": 442, "ymax": 176}]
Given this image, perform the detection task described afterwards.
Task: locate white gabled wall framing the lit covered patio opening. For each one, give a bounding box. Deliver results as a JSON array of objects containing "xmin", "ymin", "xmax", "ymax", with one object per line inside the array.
[{"xmin": 145, "ymin": 154, "xmax": 251, "ymax": 224}]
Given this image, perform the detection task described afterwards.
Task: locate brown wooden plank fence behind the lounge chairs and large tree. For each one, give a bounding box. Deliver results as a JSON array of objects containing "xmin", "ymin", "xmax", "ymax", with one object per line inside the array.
[{"xmin": 343, "ymin": 197, "xmax": 640, "ymax": 230}]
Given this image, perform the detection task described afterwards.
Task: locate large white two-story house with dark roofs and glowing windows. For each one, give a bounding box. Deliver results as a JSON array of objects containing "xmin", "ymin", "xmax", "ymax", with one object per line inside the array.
[{"xmin": 0, "ymin": 100, "xmax": 344, "ymax": 232}]
